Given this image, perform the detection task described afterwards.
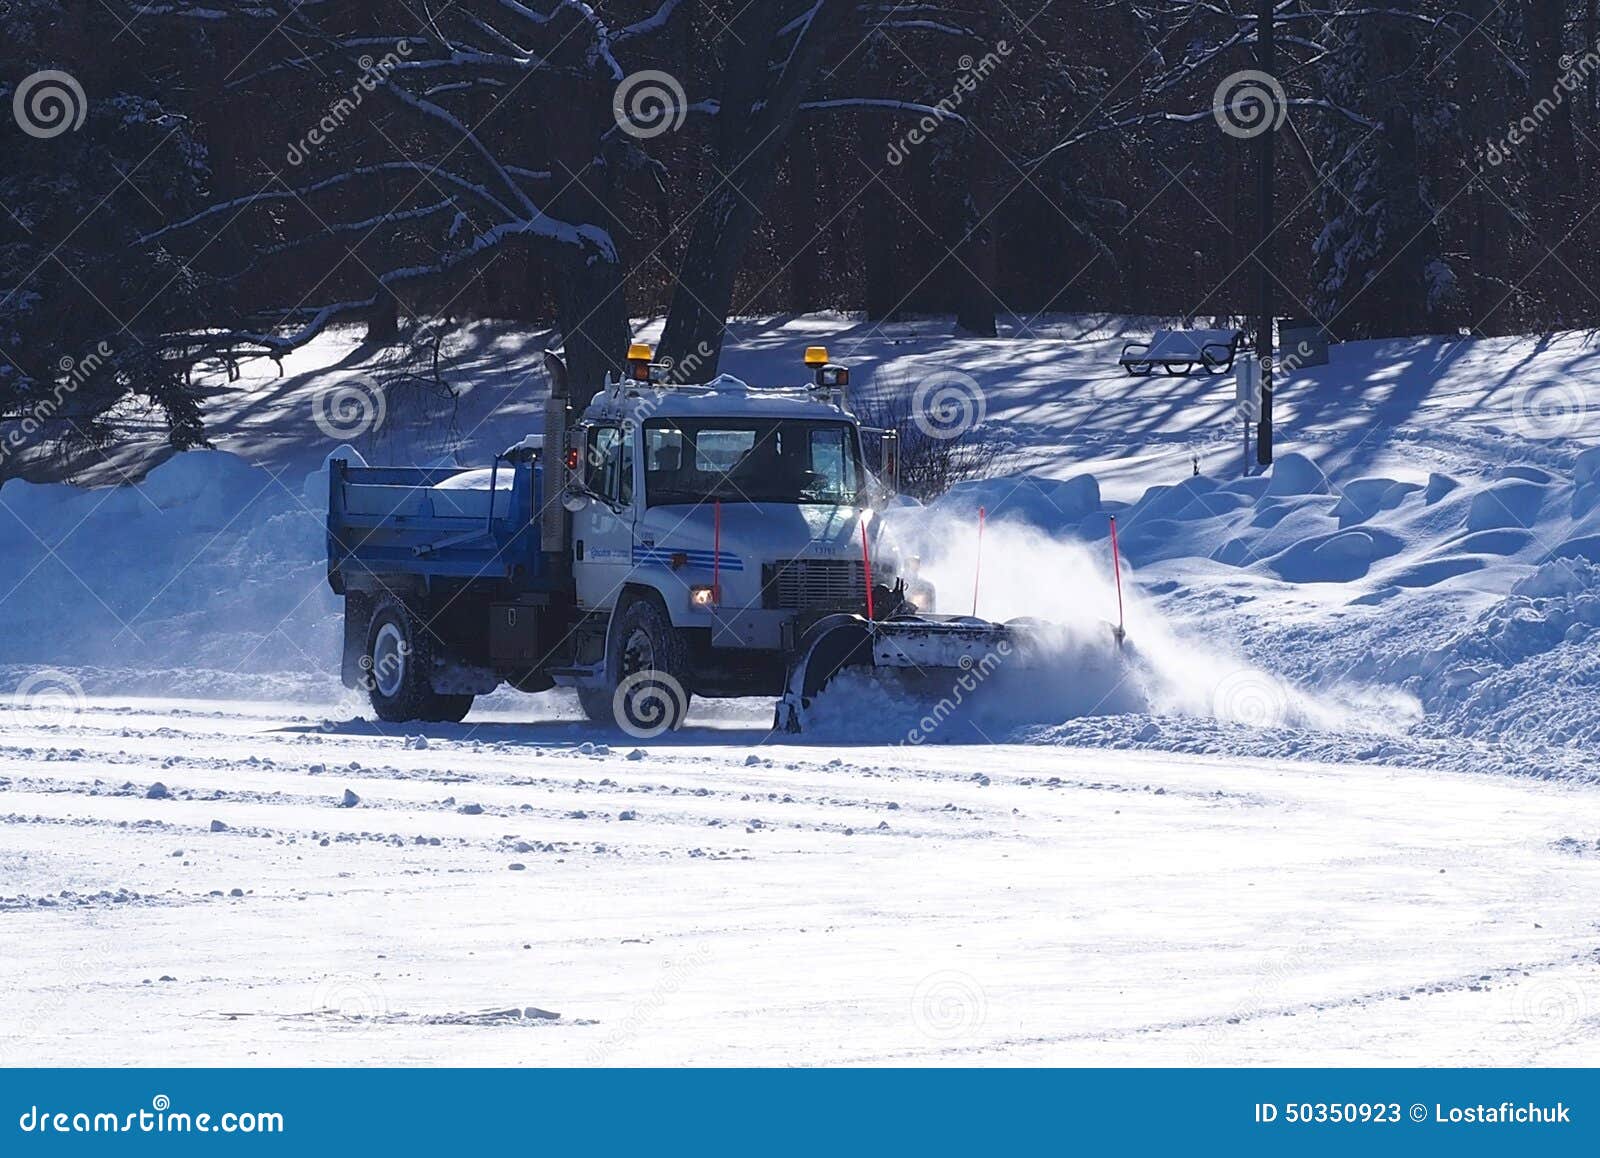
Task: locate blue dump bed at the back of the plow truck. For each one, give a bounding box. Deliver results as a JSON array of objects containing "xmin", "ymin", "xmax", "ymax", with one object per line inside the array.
[{"xmin": 328, "ymin": 459, "xmax": 547, "ymax": 592}]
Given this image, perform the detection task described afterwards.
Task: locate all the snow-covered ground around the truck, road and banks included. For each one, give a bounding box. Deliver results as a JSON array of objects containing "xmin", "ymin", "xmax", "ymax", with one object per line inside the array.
[{"xmin": 0, "ymin": 317, "xmax": 1600, "ymax": 1064}]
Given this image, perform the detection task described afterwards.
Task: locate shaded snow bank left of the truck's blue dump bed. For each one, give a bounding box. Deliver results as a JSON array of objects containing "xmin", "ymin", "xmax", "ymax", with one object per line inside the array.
[{"xmin": 0, "ymin": 451, "xmax": 339, "ymax": 683}]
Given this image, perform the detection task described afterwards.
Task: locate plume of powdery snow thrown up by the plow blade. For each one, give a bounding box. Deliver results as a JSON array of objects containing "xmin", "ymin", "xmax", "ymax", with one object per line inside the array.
[{"xmin": 838, "ymin": 509, "xmax": 1416, "ymax": 744}]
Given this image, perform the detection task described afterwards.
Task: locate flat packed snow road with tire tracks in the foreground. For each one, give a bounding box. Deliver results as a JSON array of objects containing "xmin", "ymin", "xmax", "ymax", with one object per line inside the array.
[{"xmin": 0, "ymin": 699, "xmax": 1600, "ymax": 1065}]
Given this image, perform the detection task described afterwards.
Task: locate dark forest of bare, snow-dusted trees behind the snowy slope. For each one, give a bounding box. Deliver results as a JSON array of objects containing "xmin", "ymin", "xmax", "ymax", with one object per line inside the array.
[{"xmin": 0, "ymin": 0, "xmax": 1600, "ymax": 460}]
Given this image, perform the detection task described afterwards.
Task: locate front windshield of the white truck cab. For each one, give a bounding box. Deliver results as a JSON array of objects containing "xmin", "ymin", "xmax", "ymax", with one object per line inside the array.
[{"xmin": 645, "ymin": 417, "xmax": 861, "ymax": 507}]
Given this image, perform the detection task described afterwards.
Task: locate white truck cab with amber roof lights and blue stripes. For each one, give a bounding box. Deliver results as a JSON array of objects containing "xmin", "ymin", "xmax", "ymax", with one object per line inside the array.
[{"xmin": 557, "ymin": 345, "xmax": 926, "ymax": 712}]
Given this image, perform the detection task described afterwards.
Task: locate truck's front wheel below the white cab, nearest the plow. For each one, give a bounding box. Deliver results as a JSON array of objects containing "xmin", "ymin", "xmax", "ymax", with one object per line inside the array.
[{"xmin": 578, "ymin": 597, "xmax": 690, "ymax": 739}]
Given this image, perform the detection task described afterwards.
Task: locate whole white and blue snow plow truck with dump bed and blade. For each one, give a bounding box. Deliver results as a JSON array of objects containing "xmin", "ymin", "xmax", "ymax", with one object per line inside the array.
[{"xmin": 328, "ymin": 344, "xmax": 1011, "ymax": 737}]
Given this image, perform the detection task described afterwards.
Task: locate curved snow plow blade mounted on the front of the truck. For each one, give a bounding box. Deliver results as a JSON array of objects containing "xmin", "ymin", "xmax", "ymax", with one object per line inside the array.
[{"xmin": 773, "ymin": 614, "xmax": 1094, "ymax": 733}]
